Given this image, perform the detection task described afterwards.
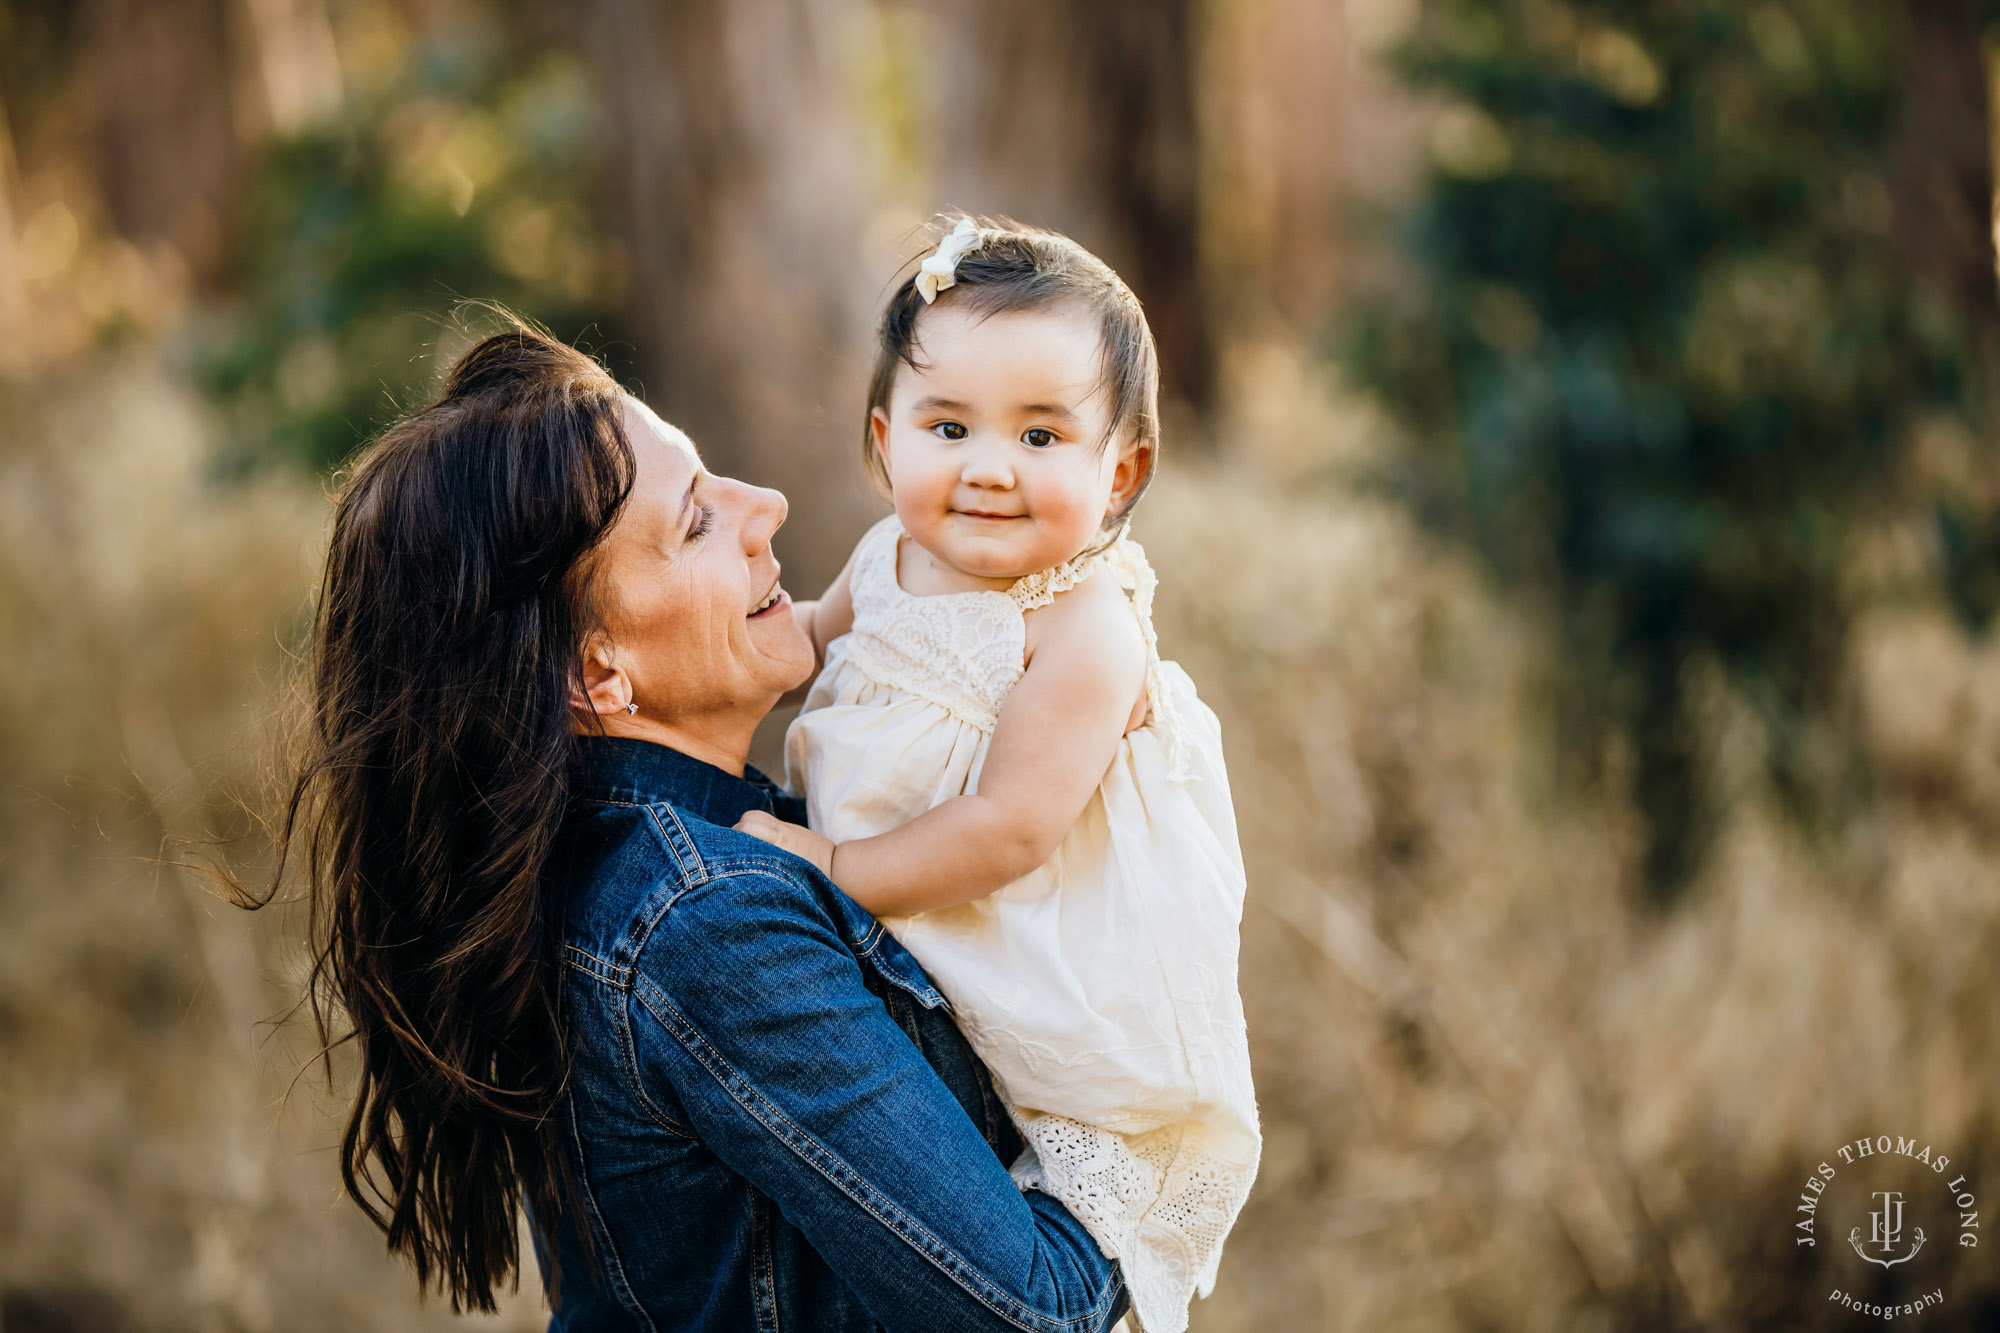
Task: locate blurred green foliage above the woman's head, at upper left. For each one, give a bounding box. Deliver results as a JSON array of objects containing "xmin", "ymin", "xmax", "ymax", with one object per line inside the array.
[{"xmin": 200, "ymin": 20, "xmax": 616, "ymax": 468}]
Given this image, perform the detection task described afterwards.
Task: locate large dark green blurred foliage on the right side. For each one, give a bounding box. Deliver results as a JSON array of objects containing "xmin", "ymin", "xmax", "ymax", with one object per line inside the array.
[{"xmin": 1352, "ymin": 0, "xmax": 1986, "ymax": 893}]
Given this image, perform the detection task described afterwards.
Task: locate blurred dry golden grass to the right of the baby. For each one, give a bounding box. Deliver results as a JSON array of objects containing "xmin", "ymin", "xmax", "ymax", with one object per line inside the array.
[{"xmin": 1136, "ymin": 348, "xmax": 2000, "ymax": 1333}]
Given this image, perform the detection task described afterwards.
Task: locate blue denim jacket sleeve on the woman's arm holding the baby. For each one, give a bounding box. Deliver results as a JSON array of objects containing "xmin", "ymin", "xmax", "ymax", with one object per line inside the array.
[{"xmin": 632, "ymin": 856, "xmax": 1124, "ymax": 1333}]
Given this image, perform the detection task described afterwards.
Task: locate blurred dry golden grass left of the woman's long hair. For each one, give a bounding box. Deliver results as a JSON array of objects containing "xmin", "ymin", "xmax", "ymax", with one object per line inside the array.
[{"xmin": 0, "ymin": 358, "xmax": 540, "ymax": 1333}]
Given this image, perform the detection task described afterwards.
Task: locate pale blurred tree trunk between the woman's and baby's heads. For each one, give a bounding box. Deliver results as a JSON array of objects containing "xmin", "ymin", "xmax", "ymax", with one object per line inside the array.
[{"xmin": 584, "ymin": 0, "xmax": 882, "ymax": 596}]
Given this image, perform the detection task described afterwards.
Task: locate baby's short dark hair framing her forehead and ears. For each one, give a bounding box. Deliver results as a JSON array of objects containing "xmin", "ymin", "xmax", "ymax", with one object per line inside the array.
[{"xmin": 862, "ymin": 214, "xmax": 1160, "ymax": 534}]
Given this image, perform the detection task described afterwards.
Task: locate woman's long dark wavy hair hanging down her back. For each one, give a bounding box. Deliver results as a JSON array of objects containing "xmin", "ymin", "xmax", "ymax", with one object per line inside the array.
[{"xmin": 258, "ymin": 326, "xmax": 632, "ymax": 1311}]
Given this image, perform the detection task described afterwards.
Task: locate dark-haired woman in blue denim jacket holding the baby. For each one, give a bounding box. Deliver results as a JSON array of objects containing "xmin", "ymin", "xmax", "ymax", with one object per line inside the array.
[{"xmin": 280, "ymin": 328, "xmax": 1126, "ymax": 1333}]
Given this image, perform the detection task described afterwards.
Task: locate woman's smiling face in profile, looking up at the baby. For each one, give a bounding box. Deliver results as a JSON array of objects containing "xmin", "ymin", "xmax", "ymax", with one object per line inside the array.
[{"xmin": 586, "ymin": 398, "xmax": 812, "ymax": 749}]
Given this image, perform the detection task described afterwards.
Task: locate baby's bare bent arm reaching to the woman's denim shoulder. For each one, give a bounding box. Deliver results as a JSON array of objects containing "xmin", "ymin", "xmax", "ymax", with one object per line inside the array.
[{"xmin": 738, "ymin": 574, "xmax": 1146, "ymax": 917}]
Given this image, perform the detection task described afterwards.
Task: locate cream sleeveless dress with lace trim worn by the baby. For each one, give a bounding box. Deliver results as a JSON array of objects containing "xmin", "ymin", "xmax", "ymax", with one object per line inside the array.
[{"xmin": 786, "ymin": 516, "xmax": 1260, "ymax": 1333}]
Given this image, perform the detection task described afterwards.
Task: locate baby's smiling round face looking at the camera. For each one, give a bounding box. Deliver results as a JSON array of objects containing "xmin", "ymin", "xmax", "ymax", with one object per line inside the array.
[{"xmin": 872, "ymin": 302, "xmax": 1142, "ymax": 584}]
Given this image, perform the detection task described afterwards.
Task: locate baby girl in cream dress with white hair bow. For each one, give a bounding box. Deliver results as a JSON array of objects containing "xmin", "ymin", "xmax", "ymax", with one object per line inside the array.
[{"xmin": 738, "ymin": 218, "xmax": 1260, "ymax": 1333}]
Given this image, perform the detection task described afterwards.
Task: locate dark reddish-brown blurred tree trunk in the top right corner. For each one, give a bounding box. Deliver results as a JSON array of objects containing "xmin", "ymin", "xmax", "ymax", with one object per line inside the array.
[{"xmin": 1888, "ymin": 0, "xmax": 2000, "ymax": 332}]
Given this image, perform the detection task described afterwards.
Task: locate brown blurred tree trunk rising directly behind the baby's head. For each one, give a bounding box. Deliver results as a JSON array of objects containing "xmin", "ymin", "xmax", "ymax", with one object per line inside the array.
[{"xmin": 938, "ymin": 0, "xmax": 1216, "ymax": 412}]
